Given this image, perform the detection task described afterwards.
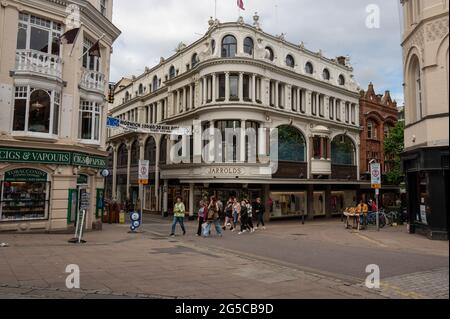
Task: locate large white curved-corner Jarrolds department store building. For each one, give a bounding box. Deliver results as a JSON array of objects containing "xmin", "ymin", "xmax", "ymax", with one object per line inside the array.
[{"xmin": 107, "ymin": 15, "xmax": 363, "ymax": 218}]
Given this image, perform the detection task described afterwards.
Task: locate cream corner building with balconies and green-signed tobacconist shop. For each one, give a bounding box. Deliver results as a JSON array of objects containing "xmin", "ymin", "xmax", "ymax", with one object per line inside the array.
[{"xmin": 0, "ymin": 0, "xmax": 120, "ymax": 231}]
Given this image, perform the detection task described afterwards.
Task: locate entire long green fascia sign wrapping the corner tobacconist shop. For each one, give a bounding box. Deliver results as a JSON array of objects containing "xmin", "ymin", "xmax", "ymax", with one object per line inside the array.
[{"xmin": 0, "ymin": 147, "xmax": 107, "ymax": 168}]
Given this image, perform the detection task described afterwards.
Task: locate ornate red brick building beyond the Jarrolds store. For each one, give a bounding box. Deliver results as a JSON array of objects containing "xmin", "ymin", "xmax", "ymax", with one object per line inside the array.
[{"xmin": 359, "ymin": 83, "xmax": 399, "ymax": 178}]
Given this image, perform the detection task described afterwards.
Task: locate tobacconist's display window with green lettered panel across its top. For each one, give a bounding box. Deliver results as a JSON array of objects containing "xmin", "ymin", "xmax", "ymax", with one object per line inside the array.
[{"xmin": 0, "ymin": 168, "xmax": 50, "ymax": 222}]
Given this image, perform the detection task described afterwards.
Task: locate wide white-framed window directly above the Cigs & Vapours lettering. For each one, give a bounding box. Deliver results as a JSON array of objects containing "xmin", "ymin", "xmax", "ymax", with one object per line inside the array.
[{"xmin": 12, "ymin": 86, "xmax": 61, "ymax": 135}]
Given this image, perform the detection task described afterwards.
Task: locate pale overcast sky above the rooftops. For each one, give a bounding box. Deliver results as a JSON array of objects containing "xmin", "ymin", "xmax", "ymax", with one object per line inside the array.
[{"xmin": 111, "ymin": 0, "xmax": 403, "ymax": 105}]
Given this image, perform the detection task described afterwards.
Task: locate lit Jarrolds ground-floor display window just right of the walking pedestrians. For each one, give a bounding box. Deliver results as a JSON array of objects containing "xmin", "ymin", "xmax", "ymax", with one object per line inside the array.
[{"xmin": 270, "ymin": 192, "xmax": 307, "ymax": 218}]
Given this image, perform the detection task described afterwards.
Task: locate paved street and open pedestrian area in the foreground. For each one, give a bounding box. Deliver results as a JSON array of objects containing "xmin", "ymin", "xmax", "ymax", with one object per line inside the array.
[{"xmin": 0, "ymin": 216, "xmax": 449, "ymax": 299}]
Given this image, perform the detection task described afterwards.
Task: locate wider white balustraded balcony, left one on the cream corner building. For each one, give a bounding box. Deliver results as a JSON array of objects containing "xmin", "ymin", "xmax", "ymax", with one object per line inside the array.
[{"xmin": 15, "ymin": 49, "xmax": 62, "ymax": 80}]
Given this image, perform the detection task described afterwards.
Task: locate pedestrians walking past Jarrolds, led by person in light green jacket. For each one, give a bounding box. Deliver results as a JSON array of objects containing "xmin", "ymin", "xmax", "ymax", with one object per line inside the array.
[{"xmin": 171, "ymin": 196, "xmax": 266, "ymax": 237}]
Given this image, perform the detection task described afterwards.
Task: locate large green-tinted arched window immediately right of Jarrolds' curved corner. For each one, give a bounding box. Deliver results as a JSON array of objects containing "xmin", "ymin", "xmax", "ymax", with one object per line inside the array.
[{"xmin": 278, "ymin": 125, "xmax": 306, "ymax": 163}]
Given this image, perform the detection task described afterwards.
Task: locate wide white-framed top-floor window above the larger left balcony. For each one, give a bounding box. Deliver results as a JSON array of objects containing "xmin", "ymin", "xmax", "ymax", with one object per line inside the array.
[{"xmin": 16, "ymin": 13, "xmax": 62, "ymax": 56}]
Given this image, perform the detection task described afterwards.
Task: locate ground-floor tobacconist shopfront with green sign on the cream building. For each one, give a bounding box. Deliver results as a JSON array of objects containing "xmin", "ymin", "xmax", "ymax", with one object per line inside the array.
[{"xmin": 0, "ymin": 146, "xmax": 106, "ymax": 232}]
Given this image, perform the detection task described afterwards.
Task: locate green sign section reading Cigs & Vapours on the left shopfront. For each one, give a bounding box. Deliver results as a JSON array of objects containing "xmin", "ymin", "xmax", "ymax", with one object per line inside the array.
[{"xmin": 0, "ymin": 149, "xmax": 71, "ymax": 165}]
